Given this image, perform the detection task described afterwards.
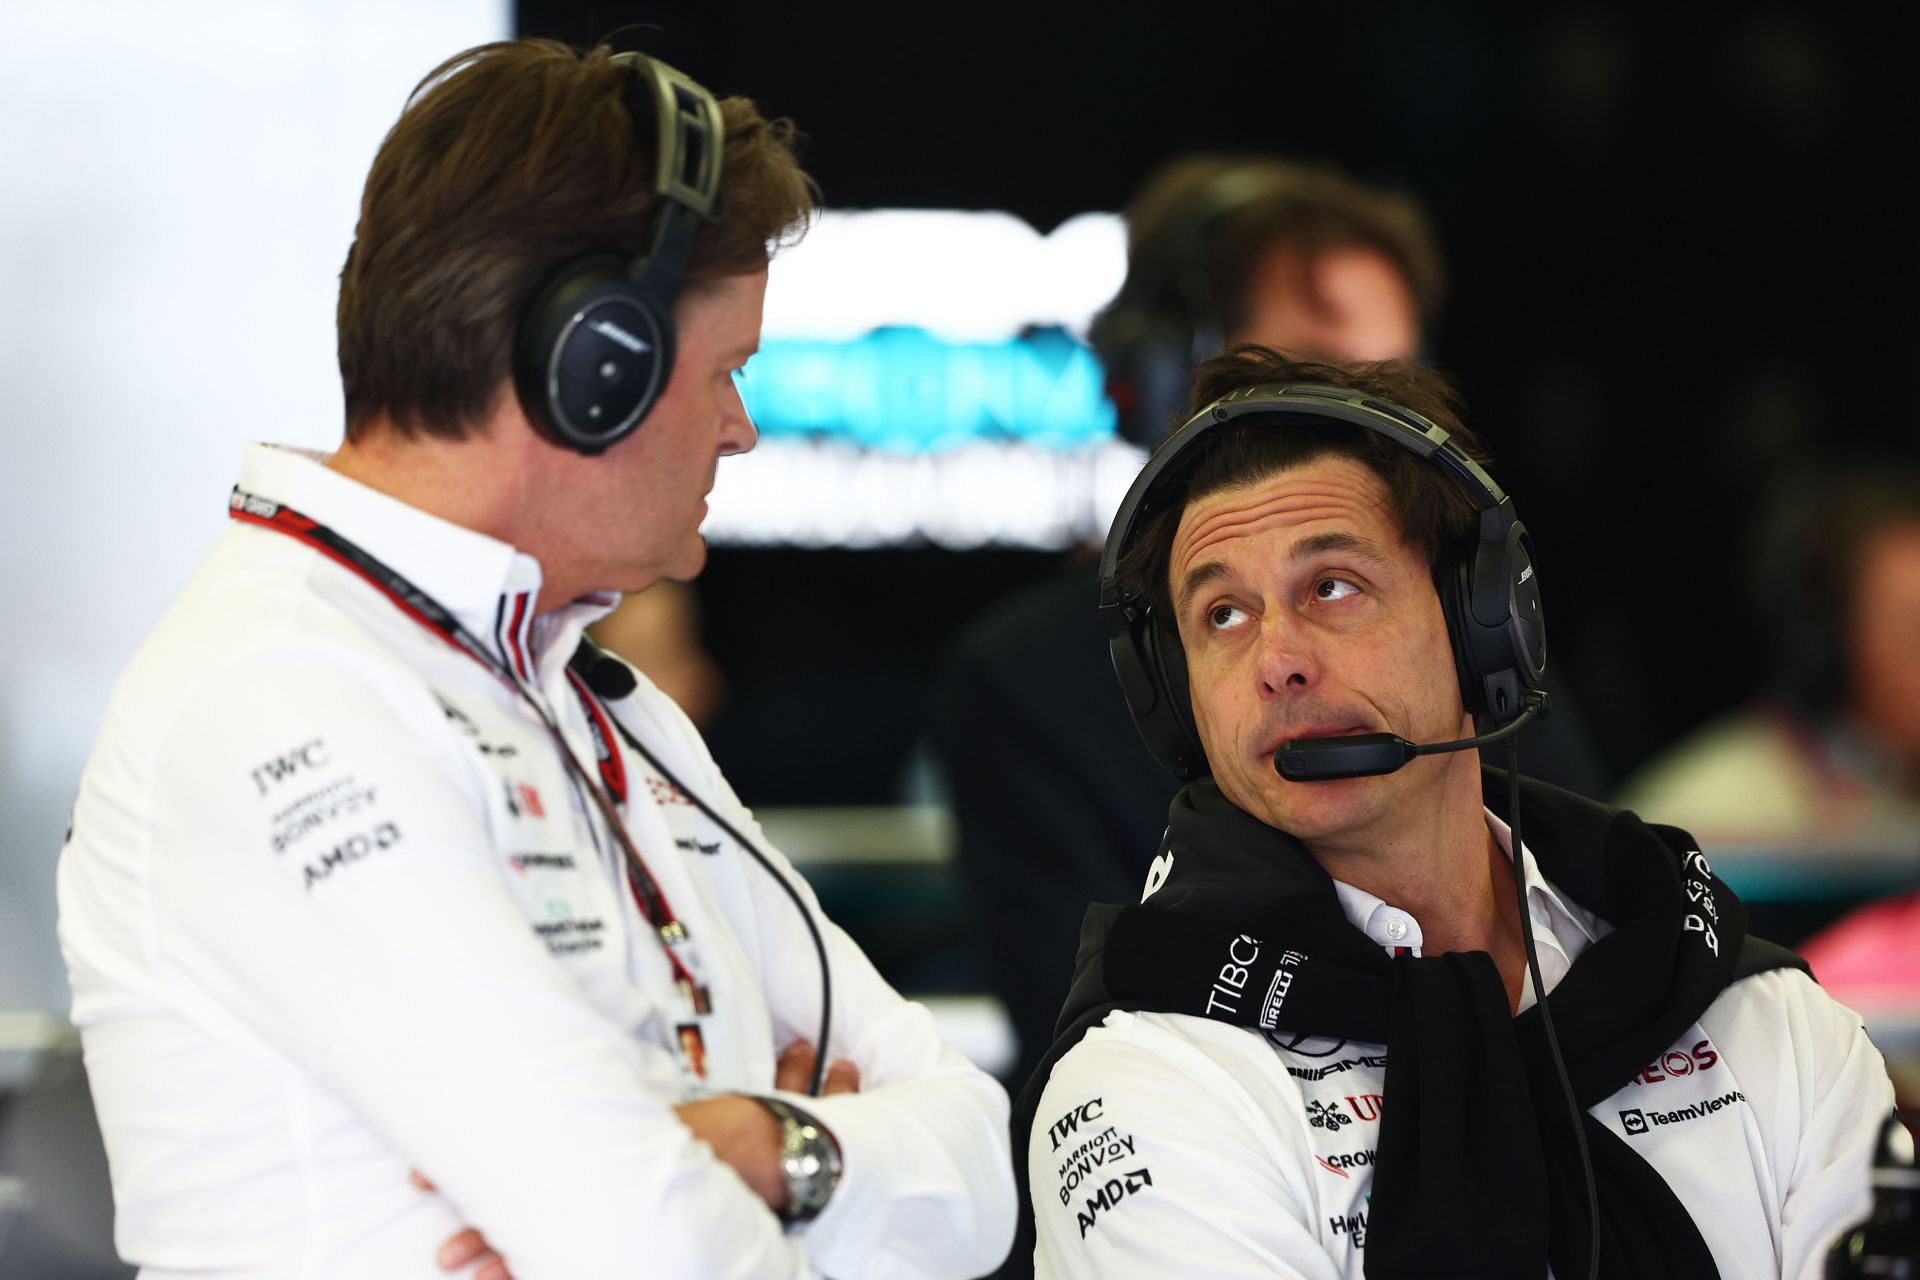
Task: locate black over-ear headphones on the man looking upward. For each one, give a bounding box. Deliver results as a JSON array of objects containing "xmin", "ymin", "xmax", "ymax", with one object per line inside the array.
[{"xmin": 1100, "ymin": 382, "xmax": 1548, "ymax": 781}]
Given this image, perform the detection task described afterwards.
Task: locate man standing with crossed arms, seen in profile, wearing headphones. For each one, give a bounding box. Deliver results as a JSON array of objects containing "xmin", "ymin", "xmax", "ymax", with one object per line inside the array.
[{"xmin": 60, "ymin": 42, "xmax": 1014, "ymax": 1278}]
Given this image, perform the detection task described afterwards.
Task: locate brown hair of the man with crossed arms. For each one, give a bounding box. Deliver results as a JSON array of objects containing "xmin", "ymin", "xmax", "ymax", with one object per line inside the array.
[{"xmin": 340, "ymin": 40, "xmax": 816, "ymax": 439}]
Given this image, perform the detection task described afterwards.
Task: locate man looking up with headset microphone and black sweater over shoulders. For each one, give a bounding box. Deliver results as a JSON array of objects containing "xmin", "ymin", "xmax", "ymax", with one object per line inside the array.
[{"xmin": 1016, "ymin": 347, "xmax": 1891, "ymax": 1280}]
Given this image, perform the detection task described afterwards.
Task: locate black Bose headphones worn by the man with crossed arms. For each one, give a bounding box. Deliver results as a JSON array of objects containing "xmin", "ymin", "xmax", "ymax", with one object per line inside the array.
[{"xmin": 513, "ymin": 54, "xmax": 724, "ymax": 455}]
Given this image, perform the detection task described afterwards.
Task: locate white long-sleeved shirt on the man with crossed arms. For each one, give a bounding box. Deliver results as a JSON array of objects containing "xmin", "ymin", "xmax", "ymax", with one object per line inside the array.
[{"xmin": 60, "ymin": 447, "xmax": 1012, "ymax": 1280}]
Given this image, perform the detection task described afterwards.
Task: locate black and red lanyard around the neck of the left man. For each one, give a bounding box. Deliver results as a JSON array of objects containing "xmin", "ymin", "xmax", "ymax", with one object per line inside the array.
[{"xmin": 227, "ymin": 486, "xmax": 712, "ymax": 1015}]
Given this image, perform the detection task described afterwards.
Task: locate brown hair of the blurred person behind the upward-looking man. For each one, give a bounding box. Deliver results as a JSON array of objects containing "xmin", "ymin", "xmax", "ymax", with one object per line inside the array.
[{"xmin": 1098, "ymin": 152, "xmax": 1446, "ymax": 345}]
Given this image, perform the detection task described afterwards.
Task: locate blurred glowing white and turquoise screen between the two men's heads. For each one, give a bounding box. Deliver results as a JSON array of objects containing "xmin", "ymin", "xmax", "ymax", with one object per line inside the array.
[{"xmin": 705, "ymin": 209, "xmax": 1142, "ymax": 549}]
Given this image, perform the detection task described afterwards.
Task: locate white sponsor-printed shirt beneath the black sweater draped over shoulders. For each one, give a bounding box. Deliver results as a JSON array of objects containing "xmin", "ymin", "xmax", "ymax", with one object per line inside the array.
[{"xmin": 1027, "ymin": 814, "xmax": 1893, "ymax": 1280}]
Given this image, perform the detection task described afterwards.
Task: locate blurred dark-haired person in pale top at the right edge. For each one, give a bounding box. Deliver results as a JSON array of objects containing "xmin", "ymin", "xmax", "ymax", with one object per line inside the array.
[{"xmin": 1620, "ymin": 464, "xmax": 1920, "ymax": 844}]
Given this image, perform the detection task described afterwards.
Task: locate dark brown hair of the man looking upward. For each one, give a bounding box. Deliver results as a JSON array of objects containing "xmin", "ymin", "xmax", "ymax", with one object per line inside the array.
[{"xmin": 1117, "ymin": 344, "xmax": 1486, "ymax": 626}]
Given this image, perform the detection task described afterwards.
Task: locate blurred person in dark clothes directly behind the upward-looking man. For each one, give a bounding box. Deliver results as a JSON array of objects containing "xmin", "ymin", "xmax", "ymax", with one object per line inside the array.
[{"xmin": 931, "ymin": 154, "xmax": 1603, "ymax": 1082}]
